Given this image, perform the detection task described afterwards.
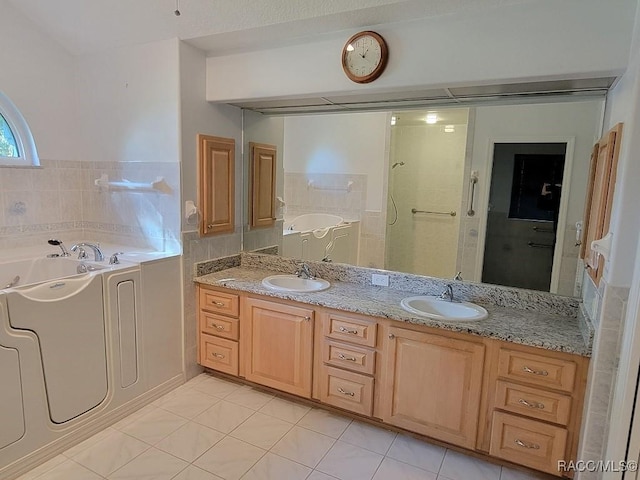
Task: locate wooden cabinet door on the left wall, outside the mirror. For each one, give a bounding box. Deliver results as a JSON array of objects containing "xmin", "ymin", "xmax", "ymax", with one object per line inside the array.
[{"xmin": 198, "ymin": 135, "xmax": 236, "ymax": 235}]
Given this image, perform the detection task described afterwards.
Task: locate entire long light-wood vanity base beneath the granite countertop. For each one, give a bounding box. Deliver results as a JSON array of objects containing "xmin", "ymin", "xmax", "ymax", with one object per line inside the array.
[{"xmin": 198, "ymin": 285, "xmax": 589, "ymax": 476}]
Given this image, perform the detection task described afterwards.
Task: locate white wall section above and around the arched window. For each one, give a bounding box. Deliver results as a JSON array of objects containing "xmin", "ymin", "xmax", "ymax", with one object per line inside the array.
[{"xmin": 0, "ymin": 0, "xmax": 78, "ymax": 160}]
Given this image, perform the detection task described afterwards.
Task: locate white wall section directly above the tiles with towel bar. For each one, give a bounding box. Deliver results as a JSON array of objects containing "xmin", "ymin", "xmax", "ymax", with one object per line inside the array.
[{"xmin": 76, "ymin": 39, "xmax": 180, "ymax": 162}]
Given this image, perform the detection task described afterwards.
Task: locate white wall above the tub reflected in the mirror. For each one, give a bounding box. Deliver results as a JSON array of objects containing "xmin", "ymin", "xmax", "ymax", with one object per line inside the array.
[{"xmin": 284, "ymin": 112, "xmax": 389, "ymax": 212}]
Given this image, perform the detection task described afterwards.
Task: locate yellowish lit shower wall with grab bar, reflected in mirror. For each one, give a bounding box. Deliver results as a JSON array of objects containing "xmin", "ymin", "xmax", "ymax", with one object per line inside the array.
[{"xmin": 386, "ymin": 124, "xmax": 467, "ymax": 278}]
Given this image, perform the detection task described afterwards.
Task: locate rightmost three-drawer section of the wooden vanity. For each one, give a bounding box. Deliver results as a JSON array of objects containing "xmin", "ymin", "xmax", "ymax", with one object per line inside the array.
[{"xmin": 479, "ymin": 342, "xmax": 588, "ymax": 475}]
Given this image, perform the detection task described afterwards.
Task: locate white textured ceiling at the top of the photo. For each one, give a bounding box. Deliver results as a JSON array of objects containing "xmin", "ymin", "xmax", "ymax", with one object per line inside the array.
[{"xmin": 7, "ymin": 0, "xmax": 541, "ymax": 56}]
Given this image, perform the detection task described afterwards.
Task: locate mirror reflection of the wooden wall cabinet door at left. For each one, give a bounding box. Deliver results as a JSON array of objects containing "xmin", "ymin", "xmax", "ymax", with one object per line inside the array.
[{"xmin": 249, "ymin": 142, "xmax": 277, "ymax": 228}]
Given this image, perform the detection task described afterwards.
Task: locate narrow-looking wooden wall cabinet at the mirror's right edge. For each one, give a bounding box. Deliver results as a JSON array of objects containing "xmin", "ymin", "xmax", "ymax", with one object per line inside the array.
[{"xmin": 580, "ymin": 123, "xmax": 622, "ymax": 285}]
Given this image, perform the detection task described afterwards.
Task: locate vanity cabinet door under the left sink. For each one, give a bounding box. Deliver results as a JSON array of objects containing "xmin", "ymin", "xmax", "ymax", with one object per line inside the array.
[{"xmin": 240, "ymin": 298, "xmax": 314, "ymax": 398}]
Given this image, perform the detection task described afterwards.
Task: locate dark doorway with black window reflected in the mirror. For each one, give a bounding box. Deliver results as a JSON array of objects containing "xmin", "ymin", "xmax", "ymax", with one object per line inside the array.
[{"xmin": 482, "ymin": 143, "xmax": 575, "ymax": 292}]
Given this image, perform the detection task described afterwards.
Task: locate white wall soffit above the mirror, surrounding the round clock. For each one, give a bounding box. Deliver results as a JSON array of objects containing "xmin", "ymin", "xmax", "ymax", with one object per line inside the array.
[{"xmin": 207, "ymin": 0, "xmax": 636, "ymax": 101}]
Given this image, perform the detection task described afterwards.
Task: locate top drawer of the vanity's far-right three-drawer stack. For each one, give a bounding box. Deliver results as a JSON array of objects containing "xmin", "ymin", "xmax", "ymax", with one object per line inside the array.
[{"xmin": 498, "ymin": 349, "xmax": 576, "ymax": 392}]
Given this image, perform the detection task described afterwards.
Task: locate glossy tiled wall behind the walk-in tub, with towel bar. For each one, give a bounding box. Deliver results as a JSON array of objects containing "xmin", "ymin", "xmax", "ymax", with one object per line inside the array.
[{"xmin": 0, "ymin": 160, "xmax": 180, "ymax": 253}]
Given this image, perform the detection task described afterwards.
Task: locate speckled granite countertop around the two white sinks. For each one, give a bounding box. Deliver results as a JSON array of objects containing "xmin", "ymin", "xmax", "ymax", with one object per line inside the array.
[{"xmin": 194, "ymin": 266, "xmax": 591, "ymax": 356}]
